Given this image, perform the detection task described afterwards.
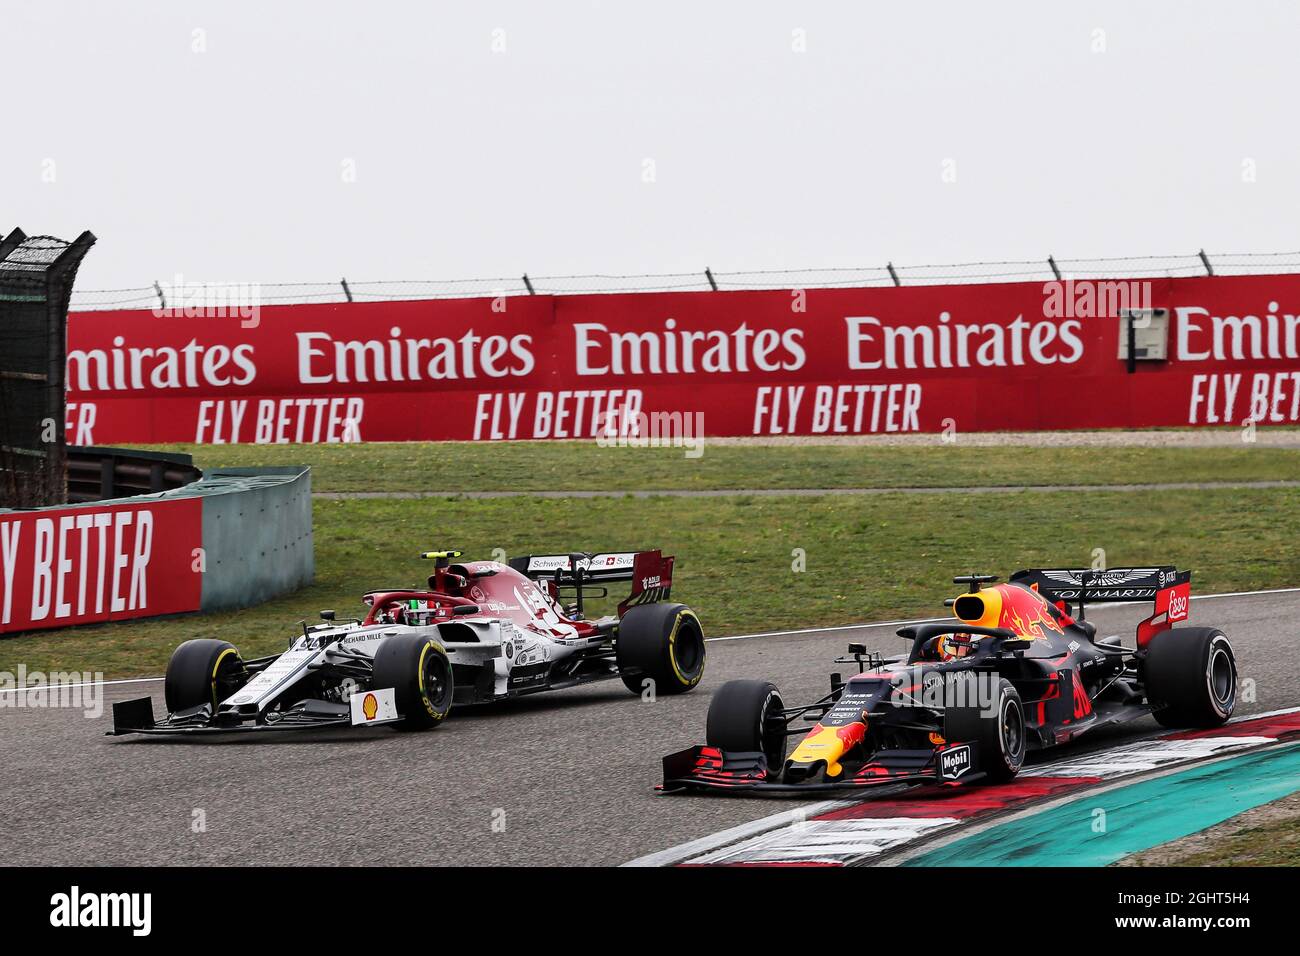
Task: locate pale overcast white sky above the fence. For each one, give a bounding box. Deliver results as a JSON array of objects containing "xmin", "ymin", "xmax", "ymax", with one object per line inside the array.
[{"xmin": 0, "ymin": 0, "xmax": 1300, "ymax": 289}]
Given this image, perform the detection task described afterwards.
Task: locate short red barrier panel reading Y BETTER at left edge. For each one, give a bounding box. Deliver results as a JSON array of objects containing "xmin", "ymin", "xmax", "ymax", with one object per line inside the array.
[{"xmin": 0, "ymin": 498, "xmax": 203, "ymax": 633}]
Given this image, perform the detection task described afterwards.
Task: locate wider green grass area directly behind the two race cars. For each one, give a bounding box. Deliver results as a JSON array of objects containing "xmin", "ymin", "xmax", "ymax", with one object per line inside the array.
[{"xmin": 0, "ymin": 489, "xmax": 1300, "ymax": 680}]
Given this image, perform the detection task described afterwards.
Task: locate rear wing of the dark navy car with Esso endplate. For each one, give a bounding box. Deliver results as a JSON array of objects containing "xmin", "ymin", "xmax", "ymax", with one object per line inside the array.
[{"xmin": 1010, "ymin": 564, "xmax": 1192, "ymax": 648}]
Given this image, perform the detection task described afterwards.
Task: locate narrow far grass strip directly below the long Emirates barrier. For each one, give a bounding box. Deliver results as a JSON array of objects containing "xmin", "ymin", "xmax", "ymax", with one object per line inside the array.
[{"xmin": 144, "ymin": 438, "xmax": 1300, "ymax": 494}]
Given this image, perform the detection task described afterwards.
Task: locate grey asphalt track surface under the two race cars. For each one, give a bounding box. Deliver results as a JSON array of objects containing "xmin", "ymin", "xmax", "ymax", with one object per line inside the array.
[{"xmin": 0, "ymin": 592, "xmax": 1300, "ymax": 865}]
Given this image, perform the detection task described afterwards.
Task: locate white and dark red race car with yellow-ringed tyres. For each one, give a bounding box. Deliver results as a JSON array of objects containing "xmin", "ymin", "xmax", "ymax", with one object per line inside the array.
[{"xmin": 112, "ymin": 550, "xmax": 705, "ymax": 734}]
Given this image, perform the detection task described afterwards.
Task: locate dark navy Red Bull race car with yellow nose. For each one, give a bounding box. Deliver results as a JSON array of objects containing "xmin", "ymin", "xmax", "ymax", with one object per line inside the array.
[{"xmin": 662, "ymin": 567, "xmax": 1236, "ymax": 792}]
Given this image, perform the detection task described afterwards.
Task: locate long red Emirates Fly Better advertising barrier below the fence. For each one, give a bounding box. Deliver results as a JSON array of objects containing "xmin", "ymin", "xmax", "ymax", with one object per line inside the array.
[{"xmin": 68, "ymin": 276, "xmax": 1300, "ymax": 445}]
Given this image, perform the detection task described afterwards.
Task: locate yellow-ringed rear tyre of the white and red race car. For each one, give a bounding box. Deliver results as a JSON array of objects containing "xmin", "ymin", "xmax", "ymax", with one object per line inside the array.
[{"xmin": 615, "ymin": 604, "xmax": 705, "ymax": 695}]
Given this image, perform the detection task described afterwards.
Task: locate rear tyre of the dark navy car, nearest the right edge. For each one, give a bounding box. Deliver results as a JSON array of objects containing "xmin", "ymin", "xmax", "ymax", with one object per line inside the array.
[{"xmin": 1143, "ymin": 627, "xmax": 1236, "ymax": 727}]
